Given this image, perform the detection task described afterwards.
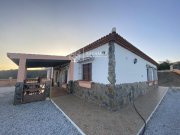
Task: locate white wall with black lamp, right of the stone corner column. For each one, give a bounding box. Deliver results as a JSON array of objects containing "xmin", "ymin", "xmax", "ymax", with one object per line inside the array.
[{"xmin": 115, "ymin": 43, "xmax": 156, "ymax": 84}]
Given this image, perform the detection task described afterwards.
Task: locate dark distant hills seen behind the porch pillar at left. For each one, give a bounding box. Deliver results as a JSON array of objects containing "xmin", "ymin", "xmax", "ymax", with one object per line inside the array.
[{"xmin": 0, "ymin": 69, "xmax": 47, "ymax": 79}]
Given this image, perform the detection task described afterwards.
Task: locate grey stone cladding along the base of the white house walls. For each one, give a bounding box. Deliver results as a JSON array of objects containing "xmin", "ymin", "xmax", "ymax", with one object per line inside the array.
[{"xmin": 73, "ymin": 81, "xmax": 157, "ymax": 110}]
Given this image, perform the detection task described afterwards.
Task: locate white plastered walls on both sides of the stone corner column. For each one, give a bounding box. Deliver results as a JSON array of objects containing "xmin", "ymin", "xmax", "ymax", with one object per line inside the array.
[{"xmin": 74, "ymin": 43, "xmax": 156, "ymax": 84}]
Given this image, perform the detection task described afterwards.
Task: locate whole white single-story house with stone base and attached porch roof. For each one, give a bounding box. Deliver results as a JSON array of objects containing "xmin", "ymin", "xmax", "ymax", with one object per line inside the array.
[{"xmin": 8, "ymin": 28, "xmax": 158, "ymax": 108}]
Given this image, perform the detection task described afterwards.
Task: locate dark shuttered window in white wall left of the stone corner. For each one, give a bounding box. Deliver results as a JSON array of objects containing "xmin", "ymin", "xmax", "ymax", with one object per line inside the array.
[{"xmin": 83, "ymin": 63, "xmax": 92, "ymax": 81}]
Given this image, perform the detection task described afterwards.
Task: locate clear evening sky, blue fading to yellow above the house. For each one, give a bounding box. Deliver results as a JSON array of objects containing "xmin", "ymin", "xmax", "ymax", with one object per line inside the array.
[{"xmin": 0, "ymin": 0, "xmax": 180, "ymax": 70}]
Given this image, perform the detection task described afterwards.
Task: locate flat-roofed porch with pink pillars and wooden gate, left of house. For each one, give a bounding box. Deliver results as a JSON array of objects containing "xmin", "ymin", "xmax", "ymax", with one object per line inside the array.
[{"xmin": 7, "ymin": 53, "xmax": 73, "ymax": 104}]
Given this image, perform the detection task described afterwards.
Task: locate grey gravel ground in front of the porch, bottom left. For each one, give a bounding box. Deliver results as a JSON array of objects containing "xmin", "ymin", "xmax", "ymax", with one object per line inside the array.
[{"xmin": 0, "ymin": 87, "xmax": 80, "ymax": 135}]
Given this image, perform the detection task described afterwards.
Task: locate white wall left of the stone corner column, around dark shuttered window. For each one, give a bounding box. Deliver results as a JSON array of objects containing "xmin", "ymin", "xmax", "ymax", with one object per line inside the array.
[{"xmin": 74, "ymin": 44, "xmax": 109, "ymax": 84}]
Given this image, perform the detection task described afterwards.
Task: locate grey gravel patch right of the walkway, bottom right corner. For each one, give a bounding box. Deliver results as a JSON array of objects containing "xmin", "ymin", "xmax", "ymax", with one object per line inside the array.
[{"xmin": 145, "ymin": 88, "xmax": 180, "ymax": 135}]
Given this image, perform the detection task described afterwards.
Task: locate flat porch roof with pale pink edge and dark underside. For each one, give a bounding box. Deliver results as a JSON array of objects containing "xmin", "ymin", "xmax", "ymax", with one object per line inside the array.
[{"xmin": 7, "ymin": 53, "xmax": 71, "ymax": 68}]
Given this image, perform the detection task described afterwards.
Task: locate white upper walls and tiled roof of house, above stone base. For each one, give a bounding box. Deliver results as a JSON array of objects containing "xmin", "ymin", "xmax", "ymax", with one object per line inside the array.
[{"xmin": 54, "ymin": 28, "xmax": 158, "ymax": 87}]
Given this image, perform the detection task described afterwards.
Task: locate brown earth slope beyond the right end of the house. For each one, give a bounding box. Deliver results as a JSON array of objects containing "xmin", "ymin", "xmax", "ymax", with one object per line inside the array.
[{"xmin": 158, "ymin": 72, "xmax": 180, "ymax": 87}]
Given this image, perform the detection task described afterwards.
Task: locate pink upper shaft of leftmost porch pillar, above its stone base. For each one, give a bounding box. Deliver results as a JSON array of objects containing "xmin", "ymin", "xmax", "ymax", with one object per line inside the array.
[{"xmin": 17, "ymin": 58, "xmax": 27, "ymax": 82}]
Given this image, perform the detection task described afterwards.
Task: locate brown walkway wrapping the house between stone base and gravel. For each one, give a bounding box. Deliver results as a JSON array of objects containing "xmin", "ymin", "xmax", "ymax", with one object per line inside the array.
[{"xmin": 52, "ymin": 87, "xmax": 168, "ymax": 135}]
